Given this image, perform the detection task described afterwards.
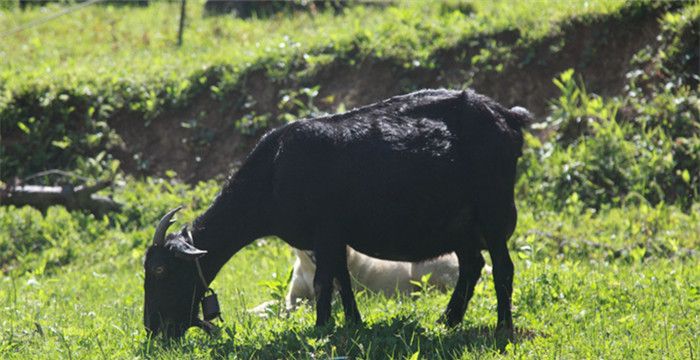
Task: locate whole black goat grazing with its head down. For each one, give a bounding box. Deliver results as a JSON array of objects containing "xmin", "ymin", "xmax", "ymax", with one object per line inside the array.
[{"xmin": 144, "ymin": 90, "xmax": 529, "ymax": 336}]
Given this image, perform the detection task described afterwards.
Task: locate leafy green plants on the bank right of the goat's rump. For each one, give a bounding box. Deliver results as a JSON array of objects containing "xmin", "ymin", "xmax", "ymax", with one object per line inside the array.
[{"xmin": 518, "ymin": 6, "xmax": 700, "ymax": 210}]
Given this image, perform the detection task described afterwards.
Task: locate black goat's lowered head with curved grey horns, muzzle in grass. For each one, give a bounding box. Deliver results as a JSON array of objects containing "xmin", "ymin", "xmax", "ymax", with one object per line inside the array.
[{"xmin": 143, "ymin": 207, "xmax": 207, "ymax": 337}]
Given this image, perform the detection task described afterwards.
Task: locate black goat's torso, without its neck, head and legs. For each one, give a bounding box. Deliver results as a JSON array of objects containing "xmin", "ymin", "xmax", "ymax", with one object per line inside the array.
[{"xmin": 241, "ymin": 90, "xmax": 522, "ymax": 261}]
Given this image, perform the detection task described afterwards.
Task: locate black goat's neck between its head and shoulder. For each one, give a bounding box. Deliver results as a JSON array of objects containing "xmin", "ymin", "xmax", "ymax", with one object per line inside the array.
[{"xmin": 192, "ymin": 187, "xmax": 265, "ymax": 284}]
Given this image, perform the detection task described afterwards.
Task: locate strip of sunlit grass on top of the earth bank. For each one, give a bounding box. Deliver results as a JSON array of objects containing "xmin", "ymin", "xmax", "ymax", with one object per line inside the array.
[{"xmin": 0, "ymin": 0, "xmax": 624, "ymax": 93}]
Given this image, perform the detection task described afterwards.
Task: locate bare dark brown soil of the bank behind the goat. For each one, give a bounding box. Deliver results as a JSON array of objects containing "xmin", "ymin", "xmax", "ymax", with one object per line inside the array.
[{"xmin": 110, "ymin": 10, "xmax": 661, "ymax": 182}]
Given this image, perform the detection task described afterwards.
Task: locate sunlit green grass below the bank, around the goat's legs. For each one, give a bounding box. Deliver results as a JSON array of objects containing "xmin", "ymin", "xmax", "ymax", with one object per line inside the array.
[{"xmin": 0, "ymin": 180, "xmax": 700, "ymax": 359}]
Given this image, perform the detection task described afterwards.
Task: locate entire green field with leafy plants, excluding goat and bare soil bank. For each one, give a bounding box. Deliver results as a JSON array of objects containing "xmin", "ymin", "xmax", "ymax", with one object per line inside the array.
[{"xmin": 0, "ymin": 1, "xmax": 700, "ymax": 359}]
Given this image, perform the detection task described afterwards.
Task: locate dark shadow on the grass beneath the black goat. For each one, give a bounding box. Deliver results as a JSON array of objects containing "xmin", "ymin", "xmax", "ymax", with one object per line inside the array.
[{"xmin": 141, "ymin": 316, "xmax": 540, "ymax": 359}]
